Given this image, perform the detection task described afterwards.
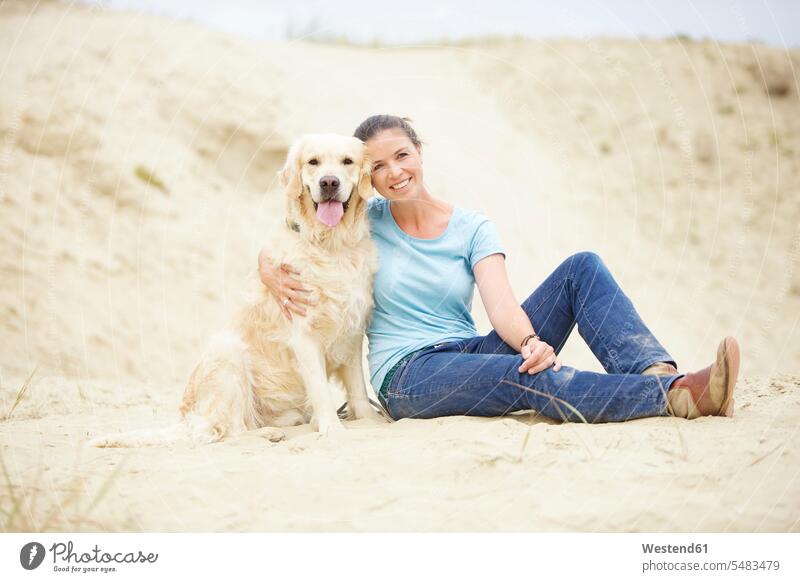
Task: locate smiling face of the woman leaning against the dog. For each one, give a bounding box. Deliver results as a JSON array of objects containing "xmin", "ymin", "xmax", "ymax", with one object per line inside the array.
[{"xmin": 366, "ymin": 128, "xmax": 422, "ymax": 200}]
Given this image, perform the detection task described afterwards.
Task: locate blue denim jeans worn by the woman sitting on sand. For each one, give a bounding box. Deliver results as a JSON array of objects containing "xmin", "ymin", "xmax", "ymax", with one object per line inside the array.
[{"xmin": 386, "ymin": 253, "xmax": 680, "ymax": 422}]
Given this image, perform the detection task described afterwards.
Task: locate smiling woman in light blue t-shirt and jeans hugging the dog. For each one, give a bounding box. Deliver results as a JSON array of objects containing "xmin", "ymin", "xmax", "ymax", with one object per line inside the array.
[{"xmin": 259, "ymin": 115, "xmax": 739, "ymax": 422}]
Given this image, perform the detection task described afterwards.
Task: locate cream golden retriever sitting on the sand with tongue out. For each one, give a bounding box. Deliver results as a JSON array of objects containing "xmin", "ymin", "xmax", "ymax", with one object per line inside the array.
[{"xmin": 89, "ymin": 135, "xmax": 380, "ymax": 447}]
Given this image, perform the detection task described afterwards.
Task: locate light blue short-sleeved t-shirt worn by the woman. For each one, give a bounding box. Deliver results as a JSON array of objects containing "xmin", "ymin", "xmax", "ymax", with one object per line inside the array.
[{"xmin": 367, "ymin": 198, "xmax": 505, "ymax": 392}]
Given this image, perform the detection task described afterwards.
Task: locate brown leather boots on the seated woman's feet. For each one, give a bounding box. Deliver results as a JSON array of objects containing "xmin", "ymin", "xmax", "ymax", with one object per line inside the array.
[{"xmin": 667, "ymin": 336, "xmax": 740, "ymax": 419}]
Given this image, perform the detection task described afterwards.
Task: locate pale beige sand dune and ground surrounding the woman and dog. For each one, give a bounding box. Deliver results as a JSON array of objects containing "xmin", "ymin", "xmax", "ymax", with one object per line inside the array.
[{"xmin": 0, "ymin": 1, "xmax": 800, "ymax": 532}]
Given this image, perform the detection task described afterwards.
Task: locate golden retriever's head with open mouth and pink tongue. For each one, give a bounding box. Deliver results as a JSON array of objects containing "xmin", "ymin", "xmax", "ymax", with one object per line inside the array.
[{"xmin": 278, "ymin": 135, "xmax": 372, "ymax": 230}]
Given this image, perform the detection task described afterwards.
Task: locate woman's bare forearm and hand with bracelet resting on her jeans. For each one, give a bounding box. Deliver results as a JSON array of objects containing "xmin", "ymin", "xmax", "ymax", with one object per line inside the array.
[{"xmin": 473, "ymin": 254, "xmax": 561, "ymax": 374}]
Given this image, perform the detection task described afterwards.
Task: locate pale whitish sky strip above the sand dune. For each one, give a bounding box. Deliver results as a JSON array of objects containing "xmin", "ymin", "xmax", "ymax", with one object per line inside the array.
[{"xmin": 80, "ymin": 0, "xmax": 800, "ymax": 47}]
